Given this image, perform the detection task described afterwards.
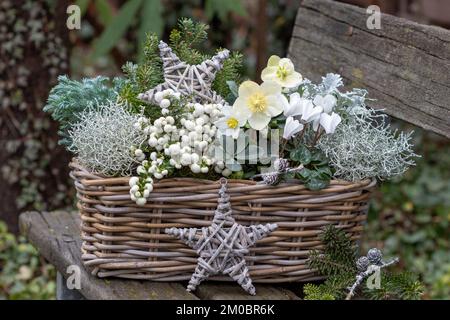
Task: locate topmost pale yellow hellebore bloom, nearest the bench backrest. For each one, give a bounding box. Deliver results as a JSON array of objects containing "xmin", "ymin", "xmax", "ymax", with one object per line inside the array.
[{"xmin": 261, "ymin": 56, "xmax": 302, "ymax": 88}]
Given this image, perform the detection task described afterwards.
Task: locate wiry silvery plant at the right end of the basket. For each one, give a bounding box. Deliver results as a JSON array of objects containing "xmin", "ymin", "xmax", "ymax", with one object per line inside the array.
[{"xmin": 317, "ymin": 106, "xmax": 417, "ymax": 181}]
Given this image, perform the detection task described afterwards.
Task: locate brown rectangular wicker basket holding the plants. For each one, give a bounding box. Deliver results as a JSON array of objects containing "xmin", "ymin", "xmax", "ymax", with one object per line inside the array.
[{"xmin": 70, "ymin": 161, "xmax": 376, "ymax": 283}]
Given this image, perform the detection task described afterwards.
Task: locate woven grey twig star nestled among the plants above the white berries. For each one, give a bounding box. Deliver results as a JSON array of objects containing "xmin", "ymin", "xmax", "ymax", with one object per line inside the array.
[{"xmin": 138, "ymin": 41, "xmax": 230, "ymax": 104}]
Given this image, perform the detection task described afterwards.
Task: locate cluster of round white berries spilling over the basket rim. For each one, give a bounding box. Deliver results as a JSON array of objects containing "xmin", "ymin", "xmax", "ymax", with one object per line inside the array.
[{"xmin": 130, "ymin": 89, "xmax": 228, "ymax": 205}]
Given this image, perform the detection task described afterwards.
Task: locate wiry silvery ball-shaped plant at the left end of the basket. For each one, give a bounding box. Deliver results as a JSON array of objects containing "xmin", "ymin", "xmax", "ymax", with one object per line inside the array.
[{"xmin": 69, "ymin": 102, "xmax": 146, "ymax": 176}]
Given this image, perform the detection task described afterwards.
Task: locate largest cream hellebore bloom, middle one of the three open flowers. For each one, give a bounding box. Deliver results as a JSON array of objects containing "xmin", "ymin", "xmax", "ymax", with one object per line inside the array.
[{"xmin": 233, "ymin": 81, "xmax": 283, "ymax": 130}]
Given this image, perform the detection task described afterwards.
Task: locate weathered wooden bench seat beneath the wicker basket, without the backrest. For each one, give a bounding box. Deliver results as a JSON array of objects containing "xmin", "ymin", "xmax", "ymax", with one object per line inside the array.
[{"xmin": 19, "ymin": 211, "xmax": 301, "ymax": 300}]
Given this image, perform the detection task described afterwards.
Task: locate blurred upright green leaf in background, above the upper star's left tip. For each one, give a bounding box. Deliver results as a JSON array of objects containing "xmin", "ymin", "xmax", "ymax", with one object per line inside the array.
[{"xmin": 138, "ymin": 0, "xmax": 164, "ymax": 61}]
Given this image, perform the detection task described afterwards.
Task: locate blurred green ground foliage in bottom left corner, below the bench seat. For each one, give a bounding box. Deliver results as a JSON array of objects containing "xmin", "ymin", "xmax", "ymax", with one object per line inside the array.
[{"xmin": 0, "ymin": 221, "xmax": 56, "ymax": 300}]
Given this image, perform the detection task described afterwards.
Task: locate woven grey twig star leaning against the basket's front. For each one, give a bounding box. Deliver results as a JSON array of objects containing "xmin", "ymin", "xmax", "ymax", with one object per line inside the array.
[{"xmin": 165, "ymin": 178, "xmax": 277, "ymax": 295}]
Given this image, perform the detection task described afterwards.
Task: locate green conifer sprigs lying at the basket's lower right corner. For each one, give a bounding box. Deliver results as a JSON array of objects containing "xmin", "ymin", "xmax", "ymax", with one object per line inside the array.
[{"xmin": 303, "ymin": 225, "xmax": 423, "ymax": 300}]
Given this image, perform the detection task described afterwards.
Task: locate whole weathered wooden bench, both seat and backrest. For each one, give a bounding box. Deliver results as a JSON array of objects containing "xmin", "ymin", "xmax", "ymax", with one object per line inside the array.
[{"xmin": 20, "ymin": 0, "xmax": 450, "ymax": 300}]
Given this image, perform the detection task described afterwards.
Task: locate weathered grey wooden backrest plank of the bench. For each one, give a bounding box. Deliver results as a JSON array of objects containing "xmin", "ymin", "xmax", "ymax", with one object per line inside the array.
[{"xmin": 289, "ymin": 0, "xmax": 450, "ymax": 138}]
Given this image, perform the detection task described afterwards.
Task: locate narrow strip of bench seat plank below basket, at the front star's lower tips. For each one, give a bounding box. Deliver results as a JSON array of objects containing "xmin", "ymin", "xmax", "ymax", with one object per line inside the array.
[{"xmin": 195, "ymin": 282, "xmax": 300, "ymax": 300}]
